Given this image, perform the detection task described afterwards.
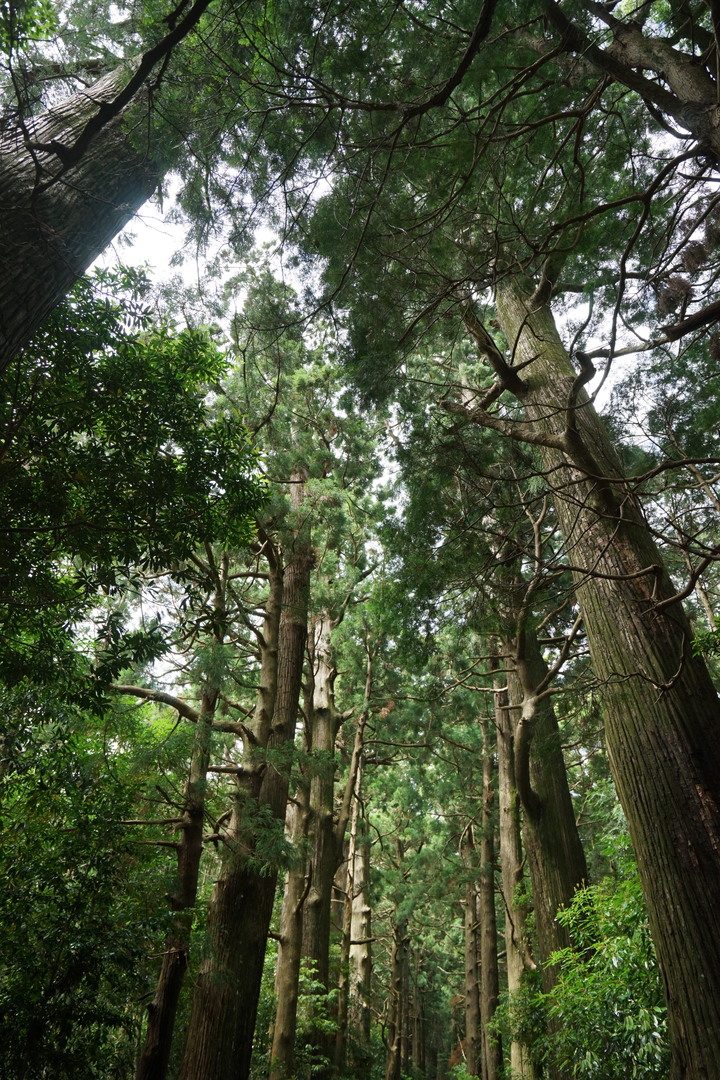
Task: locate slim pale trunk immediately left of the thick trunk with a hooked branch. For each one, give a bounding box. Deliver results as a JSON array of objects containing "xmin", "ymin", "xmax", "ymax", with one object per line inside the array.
[{"xmin": 494, "ymin": 656, "xmax": 535, "ymax": 1080}]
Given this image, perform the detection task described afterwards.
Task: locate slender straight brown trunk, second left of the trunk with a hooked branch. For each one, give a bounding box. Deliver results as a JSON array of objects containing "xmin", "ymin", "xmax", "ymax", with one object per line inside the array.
[{"xmin": 477, "ymin": 719, "xmax": 502, "ymax": 1080}]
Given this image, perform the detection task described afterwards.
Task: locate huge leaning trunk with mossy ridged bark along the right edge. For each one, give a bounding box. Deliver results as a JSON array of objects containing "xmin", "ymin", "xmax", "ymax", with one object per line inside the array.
[{"xmin": 490, "ymin": 279, "xmax": 720, "ymax": 1080}]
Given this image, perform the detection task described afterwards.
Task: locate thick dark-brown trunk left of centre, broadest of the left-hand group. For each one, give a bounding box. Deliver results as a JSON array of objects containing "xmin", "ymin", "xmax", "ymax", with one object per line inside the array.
[{"xmin": 179, "ymin": 474, "xmax": 313, "ymax": 1080}]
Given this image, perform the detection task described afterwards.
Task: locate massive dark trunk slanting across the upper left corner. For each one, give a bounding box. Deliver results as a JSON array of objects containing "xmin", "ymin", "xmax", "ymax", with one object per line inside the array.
[{"xmin": 0, "ymin": 65, "xmax": 158, "ymax": 370}]
